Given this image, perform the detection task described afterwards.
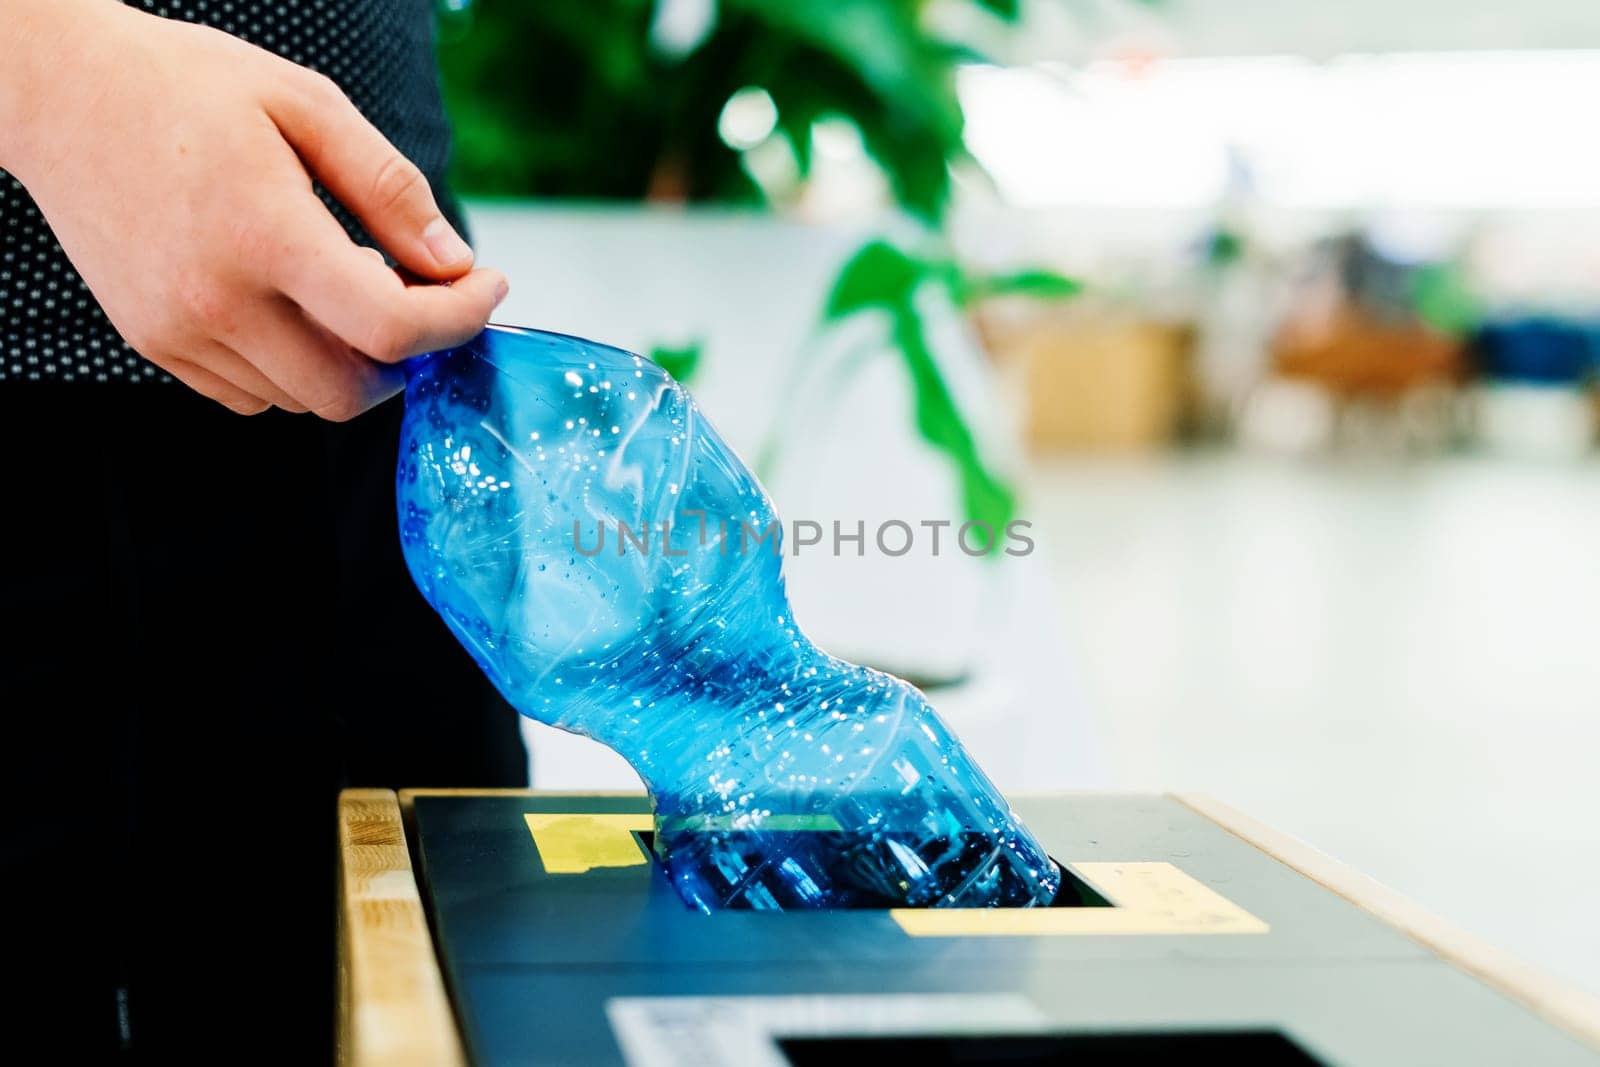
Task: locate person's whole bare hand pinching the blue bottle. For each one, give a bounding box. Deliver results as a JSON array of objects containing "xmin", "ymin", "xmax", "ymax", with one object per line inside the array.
[{"xmin": 0, "ymin": 0, "xmax": 506, "ymax": 419}]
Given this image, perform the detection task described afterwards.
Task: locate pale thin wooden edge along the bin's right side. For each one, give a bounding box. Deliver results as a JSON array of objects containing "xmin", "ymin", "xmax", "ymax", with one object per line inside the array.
[{"xmin": 1170, "ymin": 793, "xmax": 1600, "ymax": 1049}]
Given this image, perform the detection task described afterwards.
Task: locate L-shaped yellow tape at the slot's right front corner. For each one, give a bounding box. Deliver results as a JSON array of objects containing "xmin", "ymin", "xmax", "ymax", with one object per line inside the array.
[{"xmin": 890, "ymin": 862, "xmax": 1270, "ymax": 937}]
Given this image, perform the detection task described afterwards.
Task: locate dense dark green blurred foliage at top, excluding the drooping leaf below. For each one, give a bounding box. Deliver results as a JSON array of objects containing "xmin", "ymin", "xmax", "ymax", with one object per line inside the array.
[{"xmin": 440, "ymin": 0, "xmax": 1019, "ymax": 222}]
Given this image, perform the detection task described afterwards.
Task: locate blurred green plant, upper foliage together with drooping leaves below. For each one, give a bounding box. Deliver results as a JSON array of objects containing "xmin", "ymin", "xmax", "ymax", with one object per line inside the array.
[{"xmin": 440, "ymin": 0, "xmax": 1078, "ymax": 530}]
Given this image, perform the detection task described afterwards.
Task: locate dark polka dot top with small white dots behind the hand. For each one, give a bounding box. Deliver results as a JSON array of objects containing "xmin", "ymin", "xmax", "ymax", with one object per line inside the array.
[{"xmin": 0, "ymin": 0, "xmax": 450, "ymax": 382}]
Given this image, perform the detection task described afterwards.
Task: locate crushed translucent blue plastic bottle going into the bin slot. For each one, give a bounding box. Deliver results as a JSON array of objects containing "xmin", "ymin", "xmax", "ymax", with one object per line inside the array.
[{"xmin": 397, "ymin": 326, "xmax": 1059, "ymax": 910}]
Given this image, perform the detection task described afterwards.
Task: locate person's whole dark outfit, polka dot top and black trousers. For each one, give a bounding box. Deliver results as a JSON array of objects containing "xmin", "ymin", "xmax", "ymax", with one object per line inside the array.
[{"xmin": 0, "ymin": 0, "xmax": 526, "ymax": 1064}]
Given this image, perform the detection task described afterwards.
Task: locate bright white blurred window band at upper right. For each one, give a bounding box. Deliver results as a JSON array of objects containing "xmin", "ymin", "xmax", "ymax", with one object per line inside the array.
[{"xmin": 960, "ymin": 51, "xmax": 1600, "ymax": 208}]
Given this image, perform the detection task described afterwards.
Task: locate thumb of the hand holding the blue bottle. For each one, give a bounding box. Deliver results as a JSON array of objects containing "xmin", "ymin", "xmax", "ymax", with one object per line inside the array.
[{"xmin": 269, "ymin": 67, "xmax": 472, "ymax": 282}]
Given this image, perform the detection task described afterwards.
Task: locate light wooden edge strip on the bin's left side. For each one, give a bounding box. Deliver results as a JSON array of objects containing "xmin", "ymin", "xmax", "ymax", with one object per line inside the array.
[{"xmin": 334, "ymin": 789, "xmax": 467, "ymax": 1067}]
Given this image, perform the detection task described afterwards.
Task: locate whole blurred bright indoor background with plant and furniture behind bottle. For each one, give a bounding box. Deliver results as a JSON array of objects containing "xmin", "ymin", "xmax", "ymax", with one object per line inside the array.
[{"xmin": 440, "ymin": 0, "xmax": 1600, "ymax": 992}]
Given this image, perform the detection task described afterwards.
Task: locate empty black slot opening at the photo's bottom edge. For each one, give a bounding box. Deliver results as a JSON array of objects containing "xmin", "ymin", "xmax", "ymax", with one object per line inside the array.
[{"xmin": 778, "ymin": 1030, "xmax": 1322, "ymax": 1067}]
